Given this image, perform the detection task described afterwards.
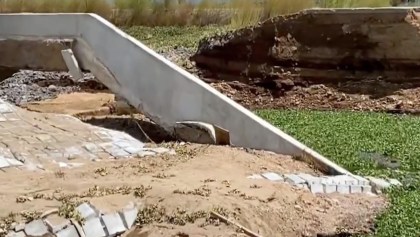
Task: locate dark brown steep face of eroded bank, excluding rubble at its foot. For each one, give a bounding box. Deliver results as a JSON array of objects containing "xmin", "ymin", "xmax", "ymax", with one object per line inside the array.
[{"xmin": 192, "ymin": 8, "xmax": 420, "ymax": 89}]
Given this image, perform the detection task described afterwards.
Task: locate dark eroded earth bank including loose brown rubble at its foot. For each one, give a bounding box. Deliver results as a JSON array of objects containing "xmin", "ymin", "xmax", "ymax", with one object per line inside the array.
[{"xmin": 192, "ymin": 9, "xmax": 420, "ymax": 112}]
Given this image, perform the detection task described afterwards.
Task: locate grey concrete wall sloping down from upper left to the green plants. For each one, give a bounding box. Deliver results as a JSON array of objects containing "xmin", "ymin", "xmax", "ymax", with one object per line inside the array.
[{"xmin": 0, "ymin": 14, "xmax": 348, "ymax": 174}]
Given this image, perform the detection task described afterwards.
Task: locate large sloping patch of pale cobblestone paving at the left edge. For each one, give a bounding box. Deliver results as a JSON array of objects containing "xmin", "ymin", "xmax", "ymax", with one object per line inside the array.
[{"xmin": 0, "ymin": 101, "xmax": 170, "ymax": 170}]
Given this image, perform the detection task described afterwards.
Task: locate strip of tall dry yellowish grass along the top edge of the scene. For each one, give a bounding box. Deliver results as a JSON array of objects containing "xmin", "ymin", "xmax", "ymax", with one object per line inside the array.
[{"xmin": 0, "ymin": 0, "xmax": 390, "ymax": 26}]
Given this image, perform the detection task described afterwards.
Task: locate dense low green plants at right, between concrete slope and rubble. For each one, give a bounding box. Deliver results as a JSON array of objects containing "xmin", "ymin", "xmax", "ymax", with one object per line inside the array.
[{"xmin": 257, "ymin": 110, "xmax": 420, "ymax": 237}]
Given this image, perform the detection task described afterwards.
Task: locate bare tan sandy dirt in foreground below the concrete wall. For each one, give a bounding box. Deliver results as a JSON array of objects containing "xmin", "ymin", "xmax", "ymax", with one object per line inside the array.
[{"xmin": 0, "ymin": 145, "xmax": 384, "ymax": 236}]
